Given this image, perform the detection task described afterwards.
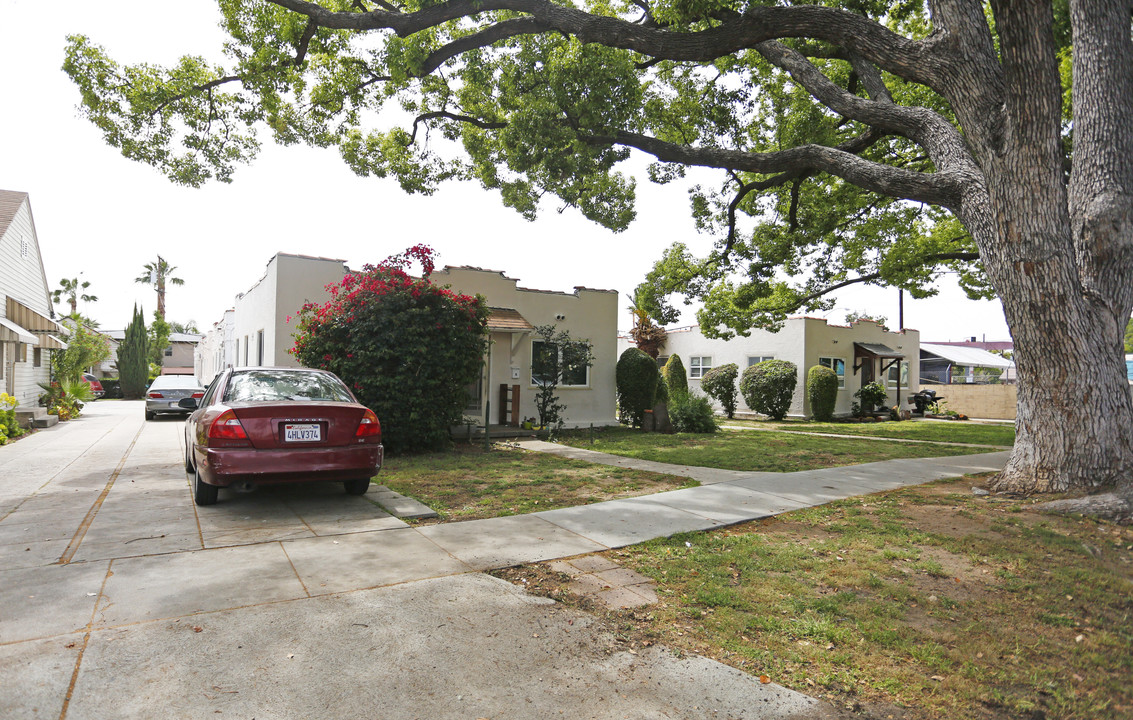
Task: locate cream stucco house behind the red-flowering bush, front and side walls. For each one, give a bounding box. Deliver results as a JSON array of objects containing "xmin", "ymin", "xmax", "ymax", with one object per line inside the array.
[{"xmin": 195, "ymin": 253, "xmax": 617, "ymax": 426}]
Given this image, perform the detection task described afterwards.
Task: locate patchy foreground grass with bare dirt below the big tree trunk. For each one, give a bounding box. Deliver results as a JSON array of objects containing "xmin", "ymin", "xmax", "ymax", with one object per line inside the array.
[{"xmin": 500, "ymin": 478, "xmax": 1133, "ymax": 720}]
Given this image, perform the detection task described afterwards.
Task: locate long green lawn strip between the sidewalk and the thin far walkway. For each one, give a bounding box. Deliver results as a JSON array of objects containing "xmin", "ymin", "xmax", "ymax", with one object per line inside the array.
[{"xmin": 556, "ymin": 423, "xmax": 1006, "ymax": 473}]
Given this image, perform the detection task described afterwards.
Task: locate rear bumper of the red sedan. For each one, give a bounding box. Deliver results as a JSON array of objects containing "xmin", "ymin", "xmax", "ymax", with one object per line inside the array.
[{"xmin": 196, "ymin": 444, "xmax": 384, "ymax": 488}]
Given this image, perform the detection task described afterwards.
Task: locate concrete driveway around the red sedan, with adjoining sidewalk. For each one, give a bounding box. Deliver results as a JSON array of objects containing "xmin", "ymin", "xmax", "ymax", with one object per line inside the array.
[{"xmin": 0, "ymin": 401, "xmax": 842, "ymax": 720}]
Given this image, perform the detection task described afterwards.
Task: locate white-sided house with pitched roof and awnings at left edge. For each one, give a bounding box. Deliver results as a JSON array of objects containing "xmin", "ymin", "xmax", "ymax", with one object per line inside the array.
[{"xmin": 0, "ymin": 190, "xmax": 67, "ymax": 407}]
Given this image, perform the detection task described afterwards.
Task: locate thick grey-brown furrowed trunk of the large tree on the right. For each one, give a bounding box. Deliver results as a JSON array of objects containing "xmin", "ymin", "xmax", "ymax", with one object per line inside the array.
[{"xmin": 966, "ymin": 0, "xmax": 1133, "ymax": 507}]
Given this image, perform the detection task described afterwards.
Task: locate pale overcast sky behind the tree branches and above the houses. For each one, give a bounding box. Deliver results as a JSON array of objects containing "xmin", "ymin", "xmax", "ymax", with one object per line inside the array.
[{"xmin": 0, "ymin": 0, "xmax": 1008, "ymax": 341}]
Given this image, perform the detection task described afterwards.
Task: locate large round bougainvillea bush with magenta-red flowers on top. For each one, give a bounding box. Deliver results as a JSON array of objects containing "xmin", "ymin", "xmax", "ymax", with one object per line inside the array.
[{"xmin": 291, "ymin": 245, "xmax": 488, "ymax": 454}]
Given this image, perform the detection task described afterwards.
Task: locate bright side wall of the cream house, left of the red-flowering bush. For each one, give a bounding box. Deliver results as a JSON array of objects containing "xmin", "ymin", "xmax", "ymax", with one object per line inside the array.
[{"xmin": 194, "ymin": 253, "xmax": 350, "ymax": 384}]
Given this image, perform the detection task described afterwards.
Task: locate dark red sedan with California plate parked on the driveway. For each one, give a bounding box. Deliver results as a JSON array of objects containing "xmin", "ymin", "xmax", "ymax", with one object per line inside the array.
[{"xmin": 180, "ymin": 367, "xmax": 383, "ymax": 505}]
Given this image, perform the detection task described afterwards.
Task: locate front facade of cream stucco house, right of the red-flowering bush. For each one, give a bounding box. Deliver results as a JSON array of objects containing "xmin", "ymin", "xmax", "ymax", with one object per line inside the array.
[{"xmin": 431, "ymin": 265, "xmax": 619, "ymax": 427}]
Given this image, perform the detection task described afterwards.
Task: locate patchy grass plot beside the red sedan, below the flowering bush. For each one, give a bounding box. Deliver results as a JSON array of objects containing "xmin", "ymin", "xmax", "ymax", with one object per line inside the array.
[{"xmin": 374, "ymin": 444, "xmax": 700, "ymax": 520}]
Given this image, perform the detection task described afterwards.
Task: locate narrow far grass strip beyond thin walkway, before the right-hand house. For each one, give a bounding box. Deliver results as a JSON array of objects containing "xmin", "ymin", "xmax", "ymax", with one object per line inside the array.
[{"xmin": 723, "ymin": 420, "xmax": 1015, "ymax": 447}]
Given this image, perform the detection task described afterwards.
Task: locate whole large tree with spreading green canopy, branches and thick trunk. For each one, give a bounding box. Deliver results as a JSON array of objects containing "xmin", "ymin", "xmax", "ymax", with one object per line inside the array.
[{"xmin": 63, "ymin": 0, "xmax": 1133, "ymax": 517}]
